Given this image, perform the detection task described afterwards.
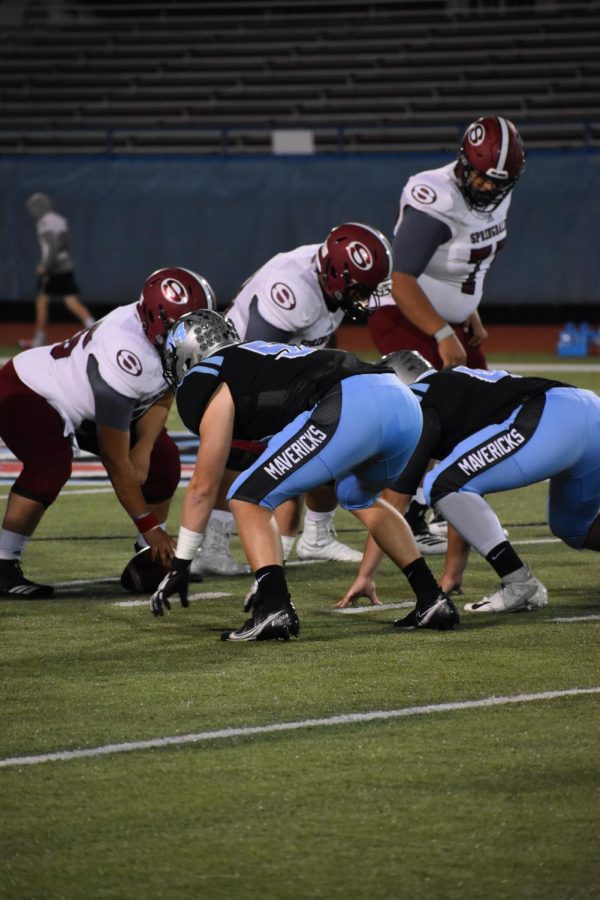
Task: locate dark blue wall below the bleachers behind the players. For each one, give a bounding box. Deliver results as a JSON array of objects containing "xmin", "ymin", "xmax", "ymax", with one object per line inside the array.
[{"xmin": 0, "ymin": 149, "xmax": 600, "ymax": 318}]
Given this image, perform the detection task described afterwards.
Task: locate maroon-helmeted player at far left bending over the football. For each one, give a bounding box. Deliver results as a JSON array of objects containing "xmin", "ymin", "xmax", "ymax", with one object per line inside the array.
[{"xmin": 0, "ymin": 268, "xmax": 216, "ymax": 599}]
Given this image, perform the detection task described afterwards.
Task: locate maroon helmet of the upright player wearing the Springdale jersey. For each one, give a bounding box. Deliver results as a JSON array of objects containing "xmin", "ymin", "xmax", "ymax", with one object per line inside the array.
[{"xmin": 455, "ymin": 116, "xmax": 525, "ymax": 212}]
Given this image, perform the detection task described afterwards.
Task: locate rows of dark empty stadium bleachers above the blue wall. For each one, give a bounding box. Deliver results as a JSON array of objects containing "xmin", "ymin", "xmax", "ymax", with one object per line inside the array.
[{"xmin": 0, "ymin": 0, "xmax": 600, "ymax": 155}]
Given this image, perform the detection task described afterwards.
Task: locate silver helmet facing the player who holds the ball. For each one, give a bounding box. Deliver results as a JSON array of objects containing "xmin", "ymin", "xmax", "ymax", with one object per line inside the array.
[{"xmin": 163, "ymin": 309, "xmax": 242, "ymax": 390}]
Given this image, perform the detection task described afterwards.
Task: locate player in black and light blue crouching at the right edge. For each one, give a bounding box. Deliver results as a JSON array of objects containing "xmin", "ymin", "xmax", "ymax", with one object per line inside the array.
[{"xmin": 339, "ymin": 350, "xmax": 600, "ymax": 626}]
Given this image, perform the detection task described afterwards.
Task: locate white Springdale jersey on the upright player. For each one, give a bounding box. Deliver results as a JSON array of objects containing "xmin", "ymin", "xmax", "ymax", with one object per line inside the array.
[{"xmin": 380, "ymin": 162, "xmax": 511, "ymax": 324}]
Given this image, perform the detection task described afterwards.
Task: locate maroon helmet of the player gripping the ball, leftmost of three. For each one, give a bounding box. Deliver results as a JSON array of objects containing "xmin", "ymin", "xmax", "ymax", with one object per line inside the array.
[{"xmin": 137, "ymin": 267, "xmax": 217, "ymax": 347}]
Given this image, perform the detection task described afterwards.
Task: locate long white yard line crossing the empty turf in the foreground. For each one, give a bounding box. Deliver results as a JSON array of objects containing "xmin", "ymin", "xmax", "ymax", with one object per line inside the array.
[{"xmin": 0, "ymin": 687, "xmax": 600, "ymax": 769}]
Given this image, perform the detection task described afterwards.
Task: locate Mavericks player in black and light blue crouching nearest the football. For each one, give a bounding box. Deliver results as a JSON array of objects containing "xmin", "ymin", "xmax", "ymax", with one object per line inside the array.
[{"xmin": 151, "ymin": 310, "xmax": 458, "ymax": 641}]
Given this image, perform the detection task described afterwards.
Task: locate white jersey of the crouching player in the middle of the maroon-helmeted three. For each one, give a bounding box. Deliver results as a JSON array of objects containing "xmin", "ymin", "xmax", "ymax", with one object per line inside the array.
[{"xmin": 227, "ymin": 244, "xmax": 344, "ymax": 347}]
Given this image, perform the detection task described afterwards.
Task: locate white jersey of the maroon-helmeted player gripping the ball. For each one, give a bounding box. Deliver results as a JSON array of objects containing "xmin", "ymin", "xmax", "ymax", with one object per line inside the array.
[{"xmin": 13, "ymin": 303, "xmax": 168, "ymax": 435}]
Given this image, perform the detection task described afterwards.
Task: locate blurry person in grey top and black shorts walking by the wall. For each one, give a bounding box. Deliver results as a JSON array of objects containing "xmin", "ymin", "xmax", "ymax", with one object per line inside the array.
[{"xmin": 19, "ymin": 193, "xmax": 95, "ymax": 347}]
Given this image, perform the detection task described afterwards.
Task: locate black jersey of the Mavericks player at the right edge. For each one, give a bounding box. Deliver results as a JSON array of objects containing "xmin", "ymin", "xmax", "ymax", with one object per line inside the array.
[{"xmin": 394, "ymin": 366, "xmax": 571, "ymax": 494}]
